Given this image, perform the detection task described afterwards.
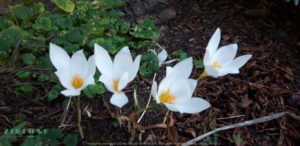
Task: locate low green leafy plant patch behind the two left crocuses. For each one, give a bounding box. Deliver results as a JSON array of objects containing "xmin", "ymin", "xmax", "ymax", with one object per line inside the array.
[{"xmin": 0, "ymin": 0, "xmax": 159, "ymax": 101}]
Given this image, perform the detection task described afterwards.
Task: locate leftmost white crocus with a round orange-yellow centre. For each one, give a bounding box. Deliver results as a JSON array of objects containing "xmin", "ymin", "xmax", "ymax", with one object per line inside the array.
[{"xmin": 49, "ymin": 43, "xmax": 96, "ymax": 97}]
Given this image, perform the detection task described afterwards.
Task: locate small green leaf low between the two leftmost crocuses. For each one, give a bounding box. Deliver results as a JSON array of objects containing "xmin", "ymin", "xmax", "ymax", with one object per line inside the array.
[{"xmin": 83, "ymin": 84, "xmax": 105, "ymax": 99}]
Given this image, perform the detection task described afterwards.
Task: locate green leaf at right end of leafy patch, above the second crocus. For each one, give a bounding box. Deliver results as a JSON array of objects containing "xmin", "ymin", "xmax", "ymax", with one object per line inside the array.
[{"xmin": 129, "ymin": 19, "xmax": 159, "ymax": 39}]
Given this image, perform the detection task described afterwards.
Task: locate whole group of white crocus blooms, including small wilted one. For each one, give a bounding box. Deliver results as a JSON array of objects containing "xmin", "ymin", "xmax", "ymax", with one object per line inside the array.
[{"xmin": 49, "ymin": 28, "xmax": 252, "ymax": 114}]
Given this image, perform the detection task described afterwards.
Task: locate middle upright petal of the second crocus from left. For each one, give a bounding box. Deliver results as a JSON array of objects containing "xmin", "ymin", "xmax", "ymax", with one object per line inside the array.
[{"xmin": 114, "ymin": 49, "xmax": 133, "ymax": 77}]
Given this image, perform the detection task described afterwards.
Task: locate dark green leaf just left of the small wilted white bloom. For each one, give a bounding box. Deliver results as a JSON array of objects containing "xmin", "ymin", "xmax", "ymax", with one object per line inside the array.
[{"xmin": 139, "ymin": 52, "xmax": 159, "ymax": 76}]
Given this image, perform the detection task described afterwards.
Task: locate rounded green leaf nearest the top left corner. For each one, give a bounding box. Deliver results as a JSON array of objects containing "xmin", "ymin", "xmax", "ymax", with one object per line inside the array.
[{"xmin": 14, "ymin": 5, "xmax": 33, "ymax": 21}]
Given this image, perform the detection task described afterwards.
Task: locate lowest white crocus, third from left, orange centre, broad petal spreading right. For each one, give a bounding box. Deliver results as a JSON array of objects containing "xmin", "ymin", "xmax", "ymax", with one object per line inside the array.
[{"xmin": 151, "ymin": 57, "xmax": 210, "ymax": 114}]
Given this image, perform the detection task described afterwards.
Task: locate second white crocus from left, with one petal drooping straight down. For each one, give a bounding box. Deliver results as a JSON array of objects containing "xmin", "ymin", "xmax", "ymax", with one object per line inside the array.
[{"xmin": 95, "ymin": 44, "xmax": 141, "ymax": 108}]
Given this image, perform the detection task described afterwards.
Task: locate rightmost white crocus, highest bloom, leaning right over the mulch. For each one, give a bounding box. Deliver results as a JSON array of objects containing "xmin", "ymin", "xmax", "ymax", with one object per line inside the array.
[{"xmin": 203, "ymin": 28, "xmax": 252, "ymax": 77}]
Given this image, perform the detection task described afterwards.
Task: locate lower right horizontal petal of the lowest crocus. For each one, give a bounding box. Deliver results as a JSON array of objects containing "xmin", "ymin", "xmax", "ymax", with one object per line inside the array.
[{"xmin": 174, "ymin": 97, "xmax": 211, "ymax": 114}]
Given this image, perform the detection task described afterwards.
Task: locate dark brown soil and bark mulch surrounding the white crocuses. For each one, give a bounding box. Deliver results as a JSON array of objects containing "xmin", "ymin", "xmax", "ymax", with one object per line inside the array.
[{"xmin": 0, "ymin": 0, "xmax": 300, "ymax": 145}]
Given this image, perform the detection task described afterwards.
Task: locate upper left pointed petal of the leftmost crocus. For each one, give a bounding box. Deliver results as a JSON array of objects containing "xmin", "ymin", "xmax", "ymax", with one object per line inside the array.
[{"xmin": 49, "ymin": 43, "xmax": 71, "ymax": 70}]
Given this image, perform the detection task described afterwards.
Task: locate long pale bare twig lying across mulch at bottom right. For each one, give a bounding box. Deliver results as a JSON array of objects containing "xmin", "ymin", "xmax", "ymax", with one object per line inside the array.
[{"xmin": 182, "ymin": 112, "xmax": 300, "ymax": 146}]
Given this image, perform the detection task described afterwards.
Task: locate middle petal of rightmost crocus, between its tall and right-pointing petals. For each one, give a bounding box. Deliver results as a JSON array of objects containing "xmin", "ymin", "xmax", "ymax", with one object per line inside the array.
[{"xmin": 210, "ymin": 44, "xmax": 237, "ymax": 65}]
